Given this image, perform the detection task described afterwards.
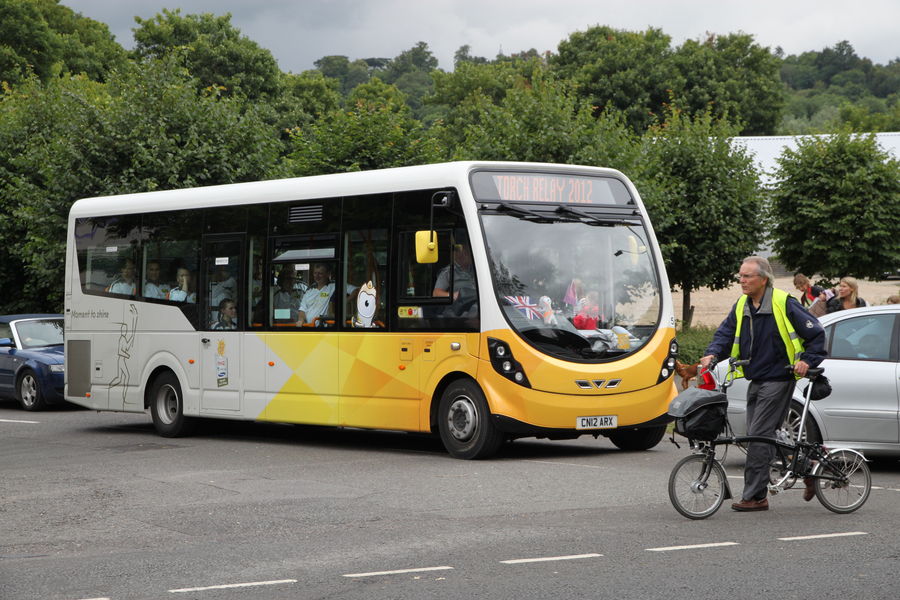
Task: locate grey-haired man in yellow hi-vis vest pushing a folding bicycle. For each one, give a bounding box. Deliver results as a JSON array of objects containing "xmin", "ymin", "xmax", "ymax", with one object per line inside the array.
[{"xmin": 700, "ymin": 256, "xmax": 827, "ymax": 512}]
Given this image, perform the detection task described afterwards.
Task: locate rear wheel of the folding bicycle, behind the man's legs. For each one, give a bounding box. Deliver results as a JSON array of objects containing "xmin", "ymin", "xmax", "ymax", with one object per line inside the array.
[{"xmin": 812, "ymin": 450, "xmax": 872, "ymax": 514}]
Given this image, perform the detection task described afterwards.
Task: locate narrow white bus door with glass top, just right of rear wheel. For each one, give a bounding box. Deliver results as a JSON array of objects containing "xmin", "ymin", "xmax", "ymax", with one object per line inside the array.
[{"xmin": 198, "ymin": 235, "xmax": 246, "ymax": 414}]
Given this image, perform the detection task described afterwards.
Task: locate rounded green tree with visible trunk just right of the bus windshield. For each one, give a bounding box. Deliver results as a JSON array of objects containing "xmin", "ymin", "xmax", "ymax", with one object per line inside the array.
[{"xmin": 635, "ymin": 108, "xmax": 764, "ymax": 329}]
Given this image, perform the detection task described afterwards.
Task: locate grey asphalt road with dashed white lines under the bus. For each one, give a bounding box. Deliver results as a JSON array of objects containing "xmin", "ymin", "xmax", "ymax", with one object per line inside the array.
[{"xmin": 0, "ymin": 401, "xmax": 900, "ymax": 600}]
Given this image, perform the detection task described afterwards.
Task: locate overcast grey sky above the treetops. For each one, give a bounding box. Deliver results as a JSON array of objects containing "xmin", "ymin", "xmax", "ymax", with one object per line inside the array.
[{"xmin": 67, "ymin": 0, "xmax": 900, "ymax": 73}]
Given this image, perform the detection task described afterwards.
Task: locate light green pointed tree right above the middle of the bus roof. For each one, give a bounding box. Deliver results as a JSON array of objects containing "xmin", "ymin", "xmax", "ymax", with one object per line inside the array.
[{"xmin": 286, "ymin": 78, "xmax": 446, "ymax": 175}]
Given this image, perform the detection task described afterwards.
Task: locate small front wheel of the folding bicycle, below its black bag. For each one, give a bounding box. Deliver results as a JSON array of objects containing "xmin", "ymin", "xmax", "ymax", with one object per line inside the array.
[{"xmin": 669, "ymin": 454, "xmax": 728, "ymax": 519}]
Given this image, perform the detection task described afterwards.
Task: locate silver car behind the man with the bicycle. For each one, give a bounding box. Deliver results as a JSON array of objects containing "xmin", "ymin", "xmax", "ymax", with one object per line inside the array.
[{"xmin": 716, "ymin": 304, "xmax": 900, "ymax": 456}]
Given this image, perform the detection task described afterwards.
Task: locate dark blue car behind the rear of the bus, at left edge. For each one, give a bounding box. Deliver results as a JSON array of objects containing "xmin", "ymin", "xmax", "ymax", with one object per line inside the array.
[{"xmin": 0, "ymin": 315, "xmax": 65, "ymax": 410}]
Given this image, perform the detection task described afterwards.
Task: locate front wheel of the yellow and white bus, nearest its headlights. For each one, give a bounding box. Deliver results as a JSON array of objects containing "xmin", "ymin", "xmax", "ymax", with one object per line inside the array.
[{"xmin": 438, "ymin": 379, "xmax": 504, "ymax": 460}]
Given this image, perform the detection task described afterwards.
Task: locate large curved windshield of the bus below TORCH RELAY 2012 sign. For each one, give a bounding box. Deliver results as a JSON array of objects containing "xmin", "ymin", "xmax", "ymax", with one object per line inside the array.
[{"xmin": 480, "ymin": 195, "xmax": 661, "ymax": 362}]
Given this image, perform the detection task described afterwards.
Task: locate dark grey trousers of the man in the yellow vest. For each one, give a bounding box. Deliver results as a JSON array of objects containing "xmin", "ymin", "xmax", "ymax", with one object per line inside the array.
[{"xmin": 741, "ymin": 381, "xmax": 794, "ymax": 500}]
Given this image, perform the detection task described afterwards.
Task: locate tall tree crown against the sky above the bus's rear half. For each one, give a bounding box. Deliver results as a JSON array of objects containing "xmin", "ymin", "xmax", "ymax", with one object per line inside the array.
[{"xmin": 134, "ymin": 9, "xmax": 280, "ymax": 99}]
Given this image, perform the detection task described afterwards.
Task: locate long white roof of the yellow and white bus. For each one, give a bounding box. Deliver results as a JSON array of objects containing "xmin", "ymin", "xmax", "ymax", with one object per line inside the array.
[{"xmin": 69, "ymin": 161, "xmax": 622, "ymax": 218}]
